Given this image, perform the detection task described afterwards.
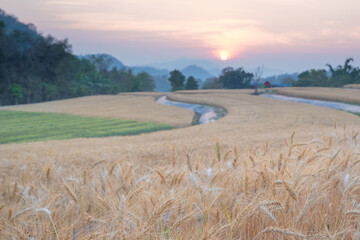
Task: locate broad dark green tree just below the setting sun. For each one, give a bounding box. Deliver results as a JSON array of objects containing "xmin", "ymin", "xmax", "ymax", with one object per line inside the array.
[{"xmin": 219, "ymin": 67, "xmax": 254, "ymax": 89}]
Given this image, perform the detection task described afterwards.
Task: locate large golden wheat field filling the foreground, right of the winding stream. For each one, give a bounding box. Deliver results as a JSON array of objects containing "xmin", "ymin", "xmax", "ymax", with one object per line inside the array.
[{"xmin": 0, "ymin": 90, "xmax": 360, "ymax": 239}]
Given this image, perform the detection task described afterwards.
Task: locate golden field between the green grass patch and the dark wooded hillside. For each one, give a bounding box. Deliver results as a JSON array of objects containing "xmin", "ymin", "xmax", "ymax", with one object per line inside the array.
[{"xmin": 0, "ymin": 93, "xmax": 194, "ymax": 128}]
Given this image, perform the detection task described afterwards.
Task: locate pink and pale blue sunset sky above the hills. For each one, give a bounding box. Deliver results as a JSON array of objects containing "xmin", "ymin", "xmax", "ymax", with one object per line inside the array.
[{"xmin": 0, "ymin": 0, "xmax": 360, "ymax": 72}]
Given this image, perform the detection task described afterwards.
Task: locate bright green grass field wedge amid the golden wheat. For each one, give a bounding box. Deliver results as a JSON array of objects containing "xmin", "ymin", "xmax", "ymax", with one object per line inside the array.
[{"xmin": 0, "ymin": 111, "xmax": 172, "ymax": 144}]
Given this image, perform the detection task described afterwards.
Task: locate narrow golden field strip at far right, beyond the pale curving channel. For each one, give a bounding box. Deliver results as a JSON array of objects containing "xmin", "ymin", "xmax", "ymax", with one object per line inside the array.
[{"xmin": 274, "ymin": 87, "xmax": 360, "ymax": 104}]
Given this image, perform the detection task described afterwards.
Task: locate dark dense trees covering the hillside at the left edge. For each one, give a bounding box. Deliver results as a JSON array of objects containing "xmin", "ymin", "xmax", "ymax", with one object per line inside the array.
[{"xmin": 0, "ymin": 17, "xmax": 155, "ymax": 105}]
